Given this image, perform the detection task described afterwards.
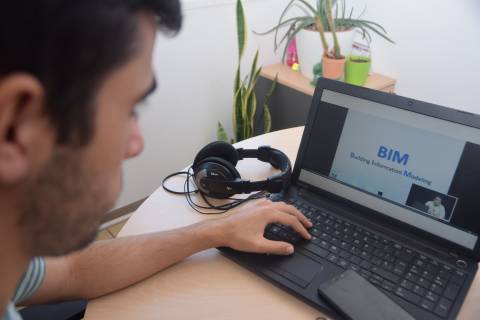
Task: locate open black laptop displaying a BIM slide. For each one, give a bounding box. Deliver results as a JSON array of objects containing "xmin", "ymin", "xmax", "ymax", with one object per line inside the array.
[{"xmin": 221, "ymin": 78, "xmax": 480, "ymax": 320}]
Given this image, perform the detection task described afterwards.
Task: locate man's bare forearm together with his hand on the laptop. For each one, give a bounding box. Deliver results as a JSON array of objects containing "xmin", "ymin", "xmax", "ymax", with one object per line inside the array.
[{"xmin": 25, "ymin": 199, "xmax": 312, "ymax": 304}]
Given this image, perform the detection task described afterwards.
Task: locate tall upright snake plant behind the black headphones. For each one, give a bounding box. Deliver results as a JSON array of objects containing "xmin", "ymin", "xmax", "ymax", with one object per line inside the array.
[{"xmin": 217, "ymin": 0, "xmax": 277, "ymax": 143}]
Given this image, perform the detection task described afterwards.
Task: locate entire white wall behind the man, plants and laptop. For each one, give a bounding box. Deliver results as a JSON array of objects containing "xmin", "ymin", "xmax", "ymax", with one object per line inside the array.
[{"xmin": 117, "ymin": 0, "xmax": 480, "ymax": 207}]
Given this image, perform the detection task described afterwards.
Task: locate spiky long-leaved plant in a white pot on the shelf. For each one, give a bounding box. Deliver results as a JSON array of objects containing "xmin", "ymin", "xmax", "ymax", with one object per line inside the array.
[{"xmin": 258, "ymin": 0, "xmax": 393, "ymax": 79}]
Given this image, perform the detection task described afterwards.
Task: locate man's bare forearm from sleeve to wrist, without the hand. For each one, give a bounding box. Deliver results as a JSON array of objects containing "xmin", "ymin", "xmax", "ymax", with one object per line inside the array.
[{"xmin": 28, "ymin": 221, "xmax": 222, "ymax": 303}]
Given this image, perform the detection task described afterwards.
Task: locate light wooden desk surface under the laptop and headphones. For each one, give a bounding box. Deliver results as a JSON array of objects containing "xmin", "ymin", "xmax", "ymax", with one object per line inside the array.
[{"xmin": 85, "ymin": 127, "xmax": 480, "ymax": 320}]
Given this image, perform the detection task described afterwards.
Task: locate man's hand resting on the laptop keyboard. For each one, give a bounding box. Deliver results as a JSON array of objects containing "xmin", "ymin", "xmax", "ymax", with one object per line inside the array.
[{"xmin": 214, "ymin": 199, "xmax": 312, "ymax": 255}]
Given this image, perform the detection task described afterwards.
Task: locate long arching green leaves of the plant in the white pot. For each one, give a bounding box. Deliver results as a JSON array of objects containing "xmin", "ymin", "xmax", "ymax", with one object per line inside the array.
[{"xmin": 256, "ymin": 0, "xmax": 394, "ymax": 59}]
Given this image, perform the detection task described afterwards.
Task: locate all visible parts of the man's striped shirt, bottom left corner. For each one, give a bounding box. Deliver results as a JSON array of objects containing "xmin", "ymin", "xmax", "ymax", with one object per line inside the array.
[{"xmin": 3, "ymin": 258, "xmax": 45, "ymax": 320}]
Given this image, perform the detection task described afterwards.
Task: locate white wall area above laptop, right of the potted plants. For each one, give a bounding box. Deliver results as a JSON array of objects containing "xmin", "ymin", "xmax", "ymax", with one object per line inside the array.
[{"xmin": 356, "ymin": 0, "xmax": 480, "ymax": 113}]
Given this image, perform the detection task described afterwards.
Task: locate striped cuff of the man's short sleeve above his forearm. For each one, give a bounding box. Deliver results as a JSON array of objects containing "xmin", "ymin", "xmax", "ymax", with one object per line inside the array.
[{"xmin": 12, "ymin": 257, "xmax": 45, "ymax": 304}]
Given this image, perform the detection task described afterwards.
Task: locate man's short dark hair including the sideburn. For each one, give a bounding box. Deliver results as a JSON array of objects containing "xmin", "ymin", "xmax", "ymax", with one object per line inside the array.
[{"xmin": 0, "ymin": 0, "xmax": 182, "ymax": 145}]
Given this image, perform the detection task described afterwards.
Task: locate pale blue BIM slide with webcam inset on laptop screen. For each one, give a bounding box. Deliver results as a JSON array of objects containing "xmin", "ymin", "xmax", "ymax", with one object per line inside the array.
[{"xmin": 329, "ymin": 110, "xmax": 465, "ymax": 221}]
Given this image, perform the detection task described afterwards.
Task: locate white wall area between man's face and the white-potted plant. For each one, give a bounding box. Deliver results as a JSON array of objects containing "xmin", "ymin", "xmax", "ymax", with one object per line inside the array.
[{"xmin": 116, "ymin": 0, "xmax": 284, "ymax": 207}]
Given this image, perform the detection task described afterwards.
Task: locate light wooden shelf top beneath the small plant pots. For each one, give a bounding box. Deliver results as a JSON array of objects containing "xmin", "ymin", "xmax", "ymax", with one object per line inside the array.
[{"xmin": 260, "ymin": 63, "xmax": 397, "ymax": 96}]
